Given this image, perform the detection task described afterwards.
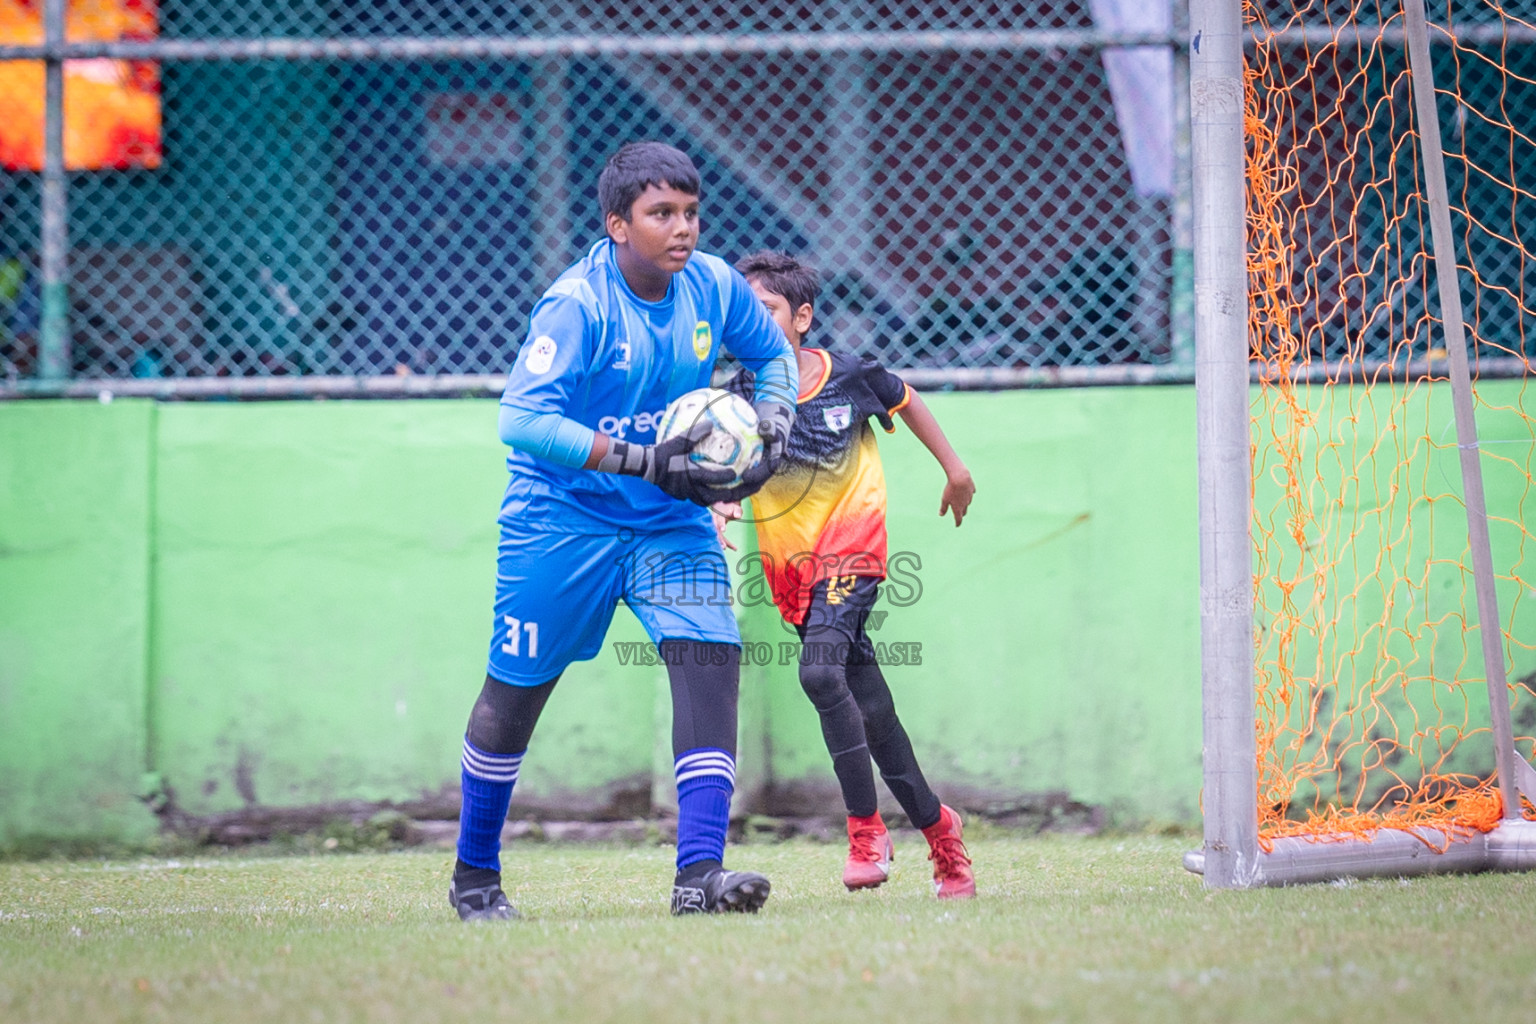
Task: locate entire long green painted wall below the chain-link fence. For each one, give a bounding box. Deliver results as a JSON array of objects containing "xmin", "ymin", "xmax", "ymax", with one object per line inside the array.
[{"xmin": 0, "ymin": 382, "xmax": 1536, "ymax": 840}]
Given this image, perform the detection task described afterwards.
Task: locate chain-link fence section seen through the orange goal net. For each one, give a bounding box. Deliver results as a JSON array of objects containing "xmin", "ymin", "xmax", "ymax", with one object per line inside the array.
[{"xmin": 1247, "ymin": 0, "xmax": 1536, "ymax": 376}]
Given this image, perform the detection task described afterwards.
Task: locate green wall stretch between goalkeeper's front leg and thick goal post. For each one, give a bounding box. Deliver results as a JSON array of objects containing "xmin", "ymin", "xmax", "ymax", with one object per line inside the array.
[{"xmin": 755, "ymin": 388, "xmax": 1200, "ymax": 821}]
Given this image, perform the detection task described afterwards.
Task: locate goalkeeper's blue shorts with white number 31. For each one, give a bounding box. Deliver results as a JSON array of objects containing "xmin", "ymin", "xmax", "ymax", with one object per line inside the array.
[{"xmin": 485, "ymin": 524, "xmax": 742, "ymax": 686}]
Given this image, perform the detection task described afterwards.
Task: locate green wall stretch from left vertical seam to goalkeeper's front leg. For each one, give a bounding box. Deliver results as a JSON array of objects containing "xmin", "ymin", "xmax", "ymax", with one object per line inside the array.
[{"xmin": 151, "ymin": 401, "xmax": 653, "ymax": 814}]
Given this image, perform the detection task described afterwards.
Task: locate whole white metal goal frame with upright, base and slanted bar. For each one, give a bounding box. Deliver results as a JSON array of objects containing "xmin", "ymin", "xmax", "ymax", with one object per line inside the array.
[{"xmin": 1184, "ymin": 0, "xmax": 1536, "ymax": 889}]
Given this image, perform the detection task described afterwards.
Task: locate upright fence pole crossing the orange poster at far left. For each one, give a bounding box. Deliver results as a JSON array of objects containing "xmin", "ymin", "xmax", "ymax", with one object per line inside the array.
[{"xmin": 37, "ymin": 0, "xmax": 69, "ymax": 379}]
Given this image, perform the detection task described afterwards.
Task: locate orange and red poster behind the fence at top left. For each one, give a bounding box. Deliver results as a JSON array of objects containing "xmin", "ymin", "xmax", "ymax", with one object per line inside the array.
[{"xmin": 0, "ymin": 0, "xmax": 160, "ymax": 170}]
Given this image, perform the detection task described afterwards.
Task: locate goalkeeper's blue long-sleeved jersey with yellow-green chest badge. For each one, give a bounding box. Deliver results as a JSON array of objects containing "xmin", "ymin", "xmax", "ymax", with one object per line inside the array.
[{"xmin": 501, "ymin": 238, "xmax": 799, "ymax": 534}]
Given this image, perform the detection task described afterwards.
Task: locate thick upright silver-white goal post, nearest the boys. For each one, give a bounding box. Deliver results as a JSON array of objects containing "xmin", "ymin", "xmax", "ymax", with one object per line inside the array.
[{"xmin": 1189, "ymin": 0, "xmax": 1258, "ymax": 889}]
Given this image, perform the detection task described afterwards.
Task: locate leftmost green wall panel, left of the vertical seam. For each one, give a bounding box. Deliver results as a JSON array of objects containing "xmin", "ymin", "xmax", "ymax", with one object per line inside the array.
[{"xmin": 0, "ymin": 402, "xmax": 157, "ymax": 838}]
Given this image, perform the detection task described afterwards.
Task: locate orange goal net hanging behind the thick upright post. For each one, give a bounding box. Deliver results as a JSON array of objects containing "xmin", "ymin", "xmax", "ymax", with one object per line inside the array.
[{"xmin": 1244, "ymin": 0, "xmax": 1536, "ymax": 849}]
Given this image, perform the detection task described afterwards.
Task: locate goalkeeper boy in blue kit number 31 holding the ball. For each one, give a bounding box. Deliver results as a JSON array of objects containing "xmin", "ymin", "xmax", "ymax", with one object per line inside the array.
[{"xmin": 449, "ymin": 143, "xmax": 799, "ymax": 920}]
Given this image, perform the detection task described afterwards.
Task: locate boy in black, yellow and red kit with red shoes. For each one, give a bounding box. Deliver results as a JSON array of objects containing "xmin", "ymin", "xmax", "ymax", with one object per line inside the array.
[{"xmin": 716, "ymin": 252, "xmax": 975, "ymax": 898}]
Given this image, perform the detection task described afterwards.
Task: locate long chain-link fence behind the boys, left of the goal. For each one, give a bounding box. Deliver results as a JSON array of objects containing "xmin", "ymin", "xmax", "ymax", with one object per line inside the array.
[{"xmin": 0, "ymin": 0, "xmax": 1189, "ymax": 391}]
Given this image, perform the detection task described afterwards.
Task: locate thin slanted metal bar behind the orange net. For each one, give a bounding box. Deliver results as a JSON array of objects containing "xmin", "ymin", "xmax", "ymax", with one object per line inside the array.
[{"xmin": 1402, "ymin": 0, "xmax": 1521, "ymax": 818}]
